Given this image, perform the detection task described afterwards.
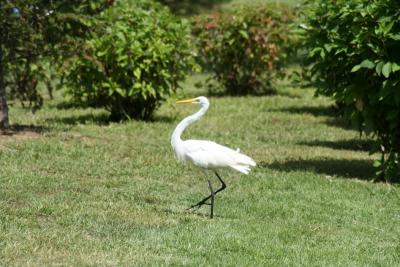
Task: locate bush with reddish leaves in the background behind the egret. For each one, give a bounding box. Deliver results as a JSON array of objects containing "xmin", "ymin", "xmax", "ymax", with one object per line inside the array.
[{"xmin": 193, "ymin": 5, "xmax": 295, "ymax": 95}]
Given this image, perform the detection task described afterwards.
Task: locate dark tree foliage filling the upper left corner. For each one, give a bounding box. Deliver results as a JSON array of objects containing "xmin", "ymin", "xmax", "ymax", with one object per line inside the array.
[{"xmin": 0, "ymin": 0, "xmax": 113, "ymax": 109}]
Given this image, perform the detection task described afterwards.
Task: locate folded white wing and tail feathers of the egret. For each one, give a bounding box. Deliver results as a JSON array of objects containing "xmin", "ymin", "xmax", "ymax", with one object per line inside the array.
[{"xmin": 184, "ymin": 140, "xmax": 256, "ymax": 174}]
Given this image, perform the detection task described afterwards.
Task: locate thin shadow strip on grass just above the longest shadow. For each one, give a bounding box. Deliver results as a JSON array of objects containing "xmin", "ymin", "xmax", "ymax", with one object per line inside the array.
[{"xmin": 298, "ymin": 139, "xmax": 371, "ymax": 152}]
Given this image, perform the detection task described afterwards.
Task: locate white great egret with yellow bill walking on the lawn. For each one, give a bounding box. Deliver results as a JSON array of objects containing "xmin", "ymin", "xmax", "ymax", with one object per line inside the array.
[{"xmin": 171, "ymin": 96, "xmax": 256, "ymax": 218}]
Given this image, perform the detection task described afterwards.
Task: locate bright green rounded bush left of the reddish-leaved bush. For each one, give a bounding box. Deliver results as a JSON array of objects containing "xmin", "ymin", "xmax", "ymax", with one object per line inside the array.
[{"xmin": 65, "ymin": 1, "xmax": 195, "ymax": 120}]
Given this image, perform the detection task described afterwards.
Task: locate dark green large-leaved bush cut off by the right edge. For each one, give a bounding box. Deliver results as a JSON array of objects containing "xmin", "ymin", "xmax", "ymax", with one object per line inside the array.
[{"xmin": 305, "ymin": 0, "xmax": 400, "ymax": 180}]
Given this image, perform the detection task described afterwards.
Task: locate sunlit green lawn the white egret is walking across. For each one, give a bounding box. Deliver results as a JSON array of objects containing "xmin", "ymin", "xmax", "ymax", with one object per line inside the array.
[{"xmin": 0, "ymin": 81, "xmax": 400, "ymax": 266}]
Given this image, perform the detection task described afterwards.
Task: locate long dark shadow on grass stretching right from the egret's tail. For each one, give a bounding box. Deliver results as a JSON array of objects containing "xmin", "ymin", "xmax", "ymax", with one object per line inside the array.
[{"xmin": 259, "ymin": 158, "xmax": 374, "ymax": 181}]
